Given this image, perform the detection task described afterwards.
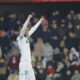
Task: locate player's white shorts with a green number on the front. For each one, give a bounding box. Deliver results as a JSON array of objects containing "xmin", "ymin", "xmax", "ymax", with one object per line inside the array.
[{"xmin": 19, "ymin": 61, "xmax": 36, "ymax": 80}]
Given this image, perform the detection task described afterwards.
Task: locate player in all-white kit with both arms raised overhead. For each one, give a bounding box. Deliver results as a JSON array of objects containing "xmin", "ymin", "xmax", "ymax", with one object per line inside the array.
[{"xmin": 17, "ymin": 14, "xmax": 44, "ymax": 80}]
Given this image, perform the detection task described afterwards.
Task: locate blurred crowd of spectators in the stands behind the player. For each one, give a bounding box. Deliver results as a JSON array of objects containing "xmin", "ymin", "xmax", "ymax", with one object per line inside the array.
[{"xmin": 0, "ymin": 10, "xmax": 80, "ymax": 80}]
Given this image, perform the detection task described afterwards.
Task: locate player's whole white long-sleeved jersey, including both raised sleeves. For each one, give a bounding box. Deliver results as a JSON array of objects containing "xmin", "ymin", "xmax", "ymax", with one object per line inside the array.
[{"xmin": 17, "ymin": 18, "xmax": 41, "ymax": 61}]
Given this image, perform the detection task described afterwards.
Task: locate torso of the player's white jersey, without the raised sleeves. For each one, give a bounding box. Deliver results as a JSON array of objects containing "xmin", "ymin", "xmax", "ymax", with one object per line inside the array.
[{"xmin": 17, "ymin": 36, "xmax": 31, "ymax": 61}]
